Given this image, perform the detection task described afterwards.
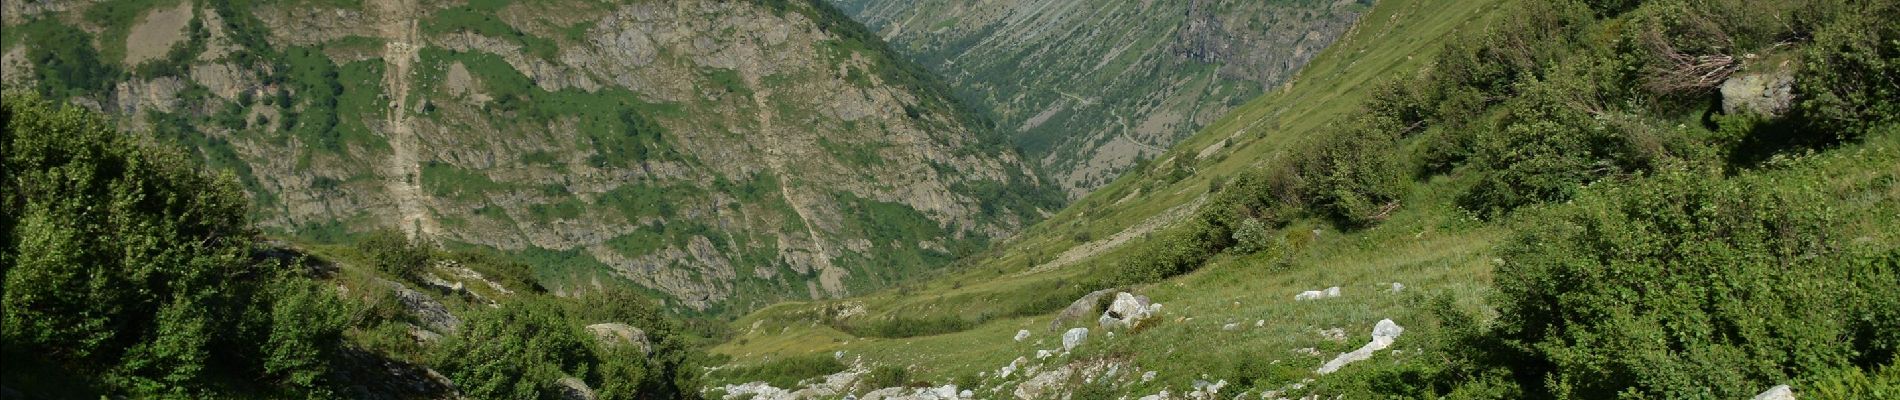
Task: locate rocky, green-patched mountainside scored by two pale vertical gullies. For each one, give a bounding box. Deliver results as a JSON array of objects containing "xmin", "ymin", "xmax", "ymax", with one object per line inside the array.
[{"xmin": 0, "ymin": 0, "xmax": 1051, "ymax": 311}]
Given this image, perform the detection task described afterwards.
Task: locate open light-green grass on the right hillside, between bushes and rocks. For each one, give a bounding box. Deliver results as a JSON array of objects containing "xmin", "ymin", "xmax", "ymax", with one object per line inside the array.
[{"xmin": 714, "ymin": 0, "xmax": 1501, "ymax": 387}]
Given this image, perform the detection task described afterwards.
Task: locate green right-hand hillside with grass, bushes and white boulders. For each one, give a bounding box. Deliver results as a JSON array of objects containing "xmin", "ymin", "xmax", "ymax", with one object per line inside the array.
[{"xmin": 713, "ymin": 0, "xmax": 1900, "ymax": 400}]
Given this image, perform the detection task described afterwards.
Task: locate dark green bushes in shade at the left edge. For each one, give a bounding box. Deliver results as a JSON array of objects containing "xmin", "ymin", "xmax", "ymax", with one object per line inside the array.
[{"xmin": 0, "ymin": 93, "xmax": 348, "ymax": 398}]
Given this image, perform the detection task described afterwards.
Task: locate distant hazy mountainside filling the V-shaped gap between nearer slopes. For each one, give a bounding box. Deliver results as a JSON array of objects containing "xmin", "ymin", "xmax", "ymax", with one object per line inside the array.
[{"xmin": 832, "ymin": 0, "xmax": 1366, "ymax": 197}]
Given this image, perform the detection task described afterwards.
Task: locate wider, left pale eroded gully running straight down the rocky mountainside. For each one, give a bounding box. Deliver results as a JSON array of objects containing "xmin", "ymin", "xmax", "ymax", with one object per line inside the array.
[{"xmin": 369, "ymin": 0, "xmax": 441, "ymax": 239}]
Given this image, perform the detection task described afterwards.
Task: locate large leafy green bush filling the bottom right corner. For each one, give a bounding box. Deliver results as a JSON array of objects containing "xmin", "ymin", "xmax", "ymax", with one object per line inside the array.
[{"xmin": 1493, "ymin": 173, "xmax": 1900, "ymax": 398}]
